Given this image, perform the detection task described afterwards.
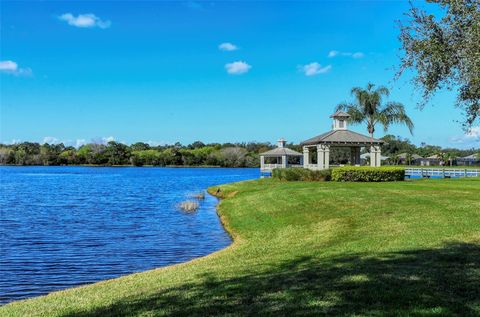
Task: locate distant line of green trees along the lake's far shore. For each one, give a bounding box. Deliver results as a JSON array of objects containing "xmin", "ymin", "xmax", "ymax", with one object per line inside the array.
[{"xmin": 0, "ymin": 135, "xmax": 480, "ymax": 167}]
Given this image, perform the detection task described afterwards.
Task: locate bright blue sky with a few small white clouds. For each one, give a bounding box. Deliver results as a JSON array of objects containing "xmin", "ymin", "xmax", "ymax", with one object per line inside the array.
[{"xmin": 0, "ymin": 1, "xmax": 480, "ymax": 148}]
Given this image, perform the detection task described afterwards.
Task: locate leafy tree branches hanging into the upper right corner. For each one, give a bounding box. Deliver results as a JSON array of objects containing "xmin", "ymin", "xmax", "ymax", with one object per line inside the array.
[{"xmin": 397, "ymin": 0, "xmax": 480, "ymax": 128}]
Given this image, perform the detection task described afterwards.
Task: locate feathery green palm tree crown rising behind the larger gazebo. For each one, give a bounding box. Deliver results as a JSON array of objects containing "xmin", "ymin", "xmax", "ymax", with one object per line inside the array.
[{"xmin": 336, "ymin": 83, "xmax": 413, "ymax": 139}]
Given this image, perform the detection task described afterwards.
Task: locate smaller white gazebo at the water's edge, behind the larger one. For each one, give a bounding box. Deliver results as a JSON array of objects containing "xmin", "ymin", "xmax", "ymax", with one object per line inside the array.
[{"xmin": 260, "ymin": 138, "xmax": 303, "ymax": 172}]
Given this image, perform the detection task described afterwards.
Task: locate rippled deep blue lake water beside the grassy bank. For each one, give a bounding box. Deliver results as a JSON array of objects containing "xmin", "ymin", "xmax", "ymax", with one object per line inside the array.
[{"xmin": 0, "ymin": 167, "xmax": 259, "ymax": 304}]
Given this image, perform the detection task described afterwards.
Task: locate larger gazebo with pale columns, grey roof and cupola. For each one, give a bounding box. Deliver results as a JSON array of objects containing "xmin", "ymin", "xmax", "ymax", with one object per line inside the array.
[{"xmin": 301, "ymin": 111, "xmax": 385, "ymax": 169}]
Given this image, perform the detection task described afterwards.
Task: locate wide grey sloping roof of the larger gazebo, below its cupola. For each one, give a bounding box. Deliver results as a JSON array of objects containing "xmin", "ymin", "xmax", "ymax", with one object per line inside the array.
[{"xmin": 301, "ymin": 128, "xmax": 385, "ymax": 145}]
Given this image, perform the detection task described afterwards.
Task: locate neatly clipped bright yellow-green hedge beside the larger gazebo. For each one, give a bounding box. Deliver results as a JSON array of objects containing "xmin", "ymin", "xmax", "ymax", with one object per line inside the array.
[{"xmin": 332, "ymin": 166, "xmax": 405, "ymax": 182}]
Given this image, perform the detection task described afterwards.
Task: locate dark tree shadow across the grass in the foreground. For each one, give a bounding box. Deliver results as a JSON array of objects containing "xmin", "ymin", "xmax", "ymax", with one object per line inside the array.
[{"xmin": 64, "ymin": 244, "xmax": 480, "ymax": 316}]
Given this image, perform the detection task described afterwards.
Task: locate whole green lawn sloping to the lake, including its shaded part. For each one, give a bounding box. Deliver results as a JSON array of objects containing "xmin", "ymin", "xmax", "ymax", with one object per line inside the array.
[{"xmin": 0, "ymin": 178, "xmax": 480, "ymax": 316}]
